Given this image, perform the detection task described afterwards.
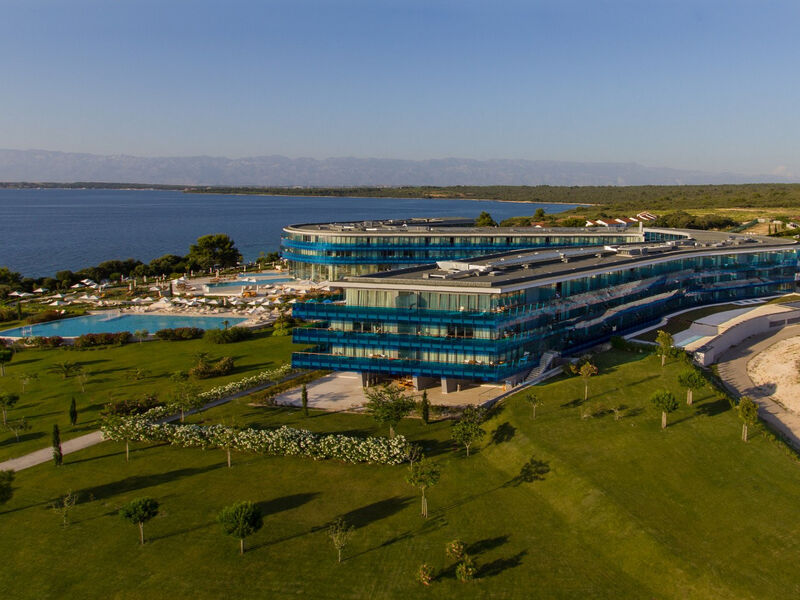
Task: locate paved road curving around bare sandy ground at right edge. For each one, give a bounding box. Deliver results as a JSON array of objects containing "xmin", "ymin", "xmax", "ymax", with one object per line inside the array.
[{"xmin": 717, "ymin": 325, "xmax": 800, "ymax": 449}]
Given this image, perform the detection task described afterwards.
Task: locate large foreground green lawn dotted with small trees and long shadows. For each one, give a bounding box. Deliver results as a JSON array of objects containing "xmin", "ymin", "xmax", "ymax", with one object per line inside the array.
[{"xmin": 0, "ymin": 352, "xmax": 800, "ymax": 599}]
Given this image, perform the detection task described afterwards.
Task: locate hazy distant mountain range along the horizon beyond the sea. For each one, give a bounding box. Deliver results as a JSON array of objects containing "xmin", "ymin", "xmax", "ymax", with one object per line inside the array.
[{"xmin": 0, "ymin": 149, "xmax": 796, "ymax": 187}]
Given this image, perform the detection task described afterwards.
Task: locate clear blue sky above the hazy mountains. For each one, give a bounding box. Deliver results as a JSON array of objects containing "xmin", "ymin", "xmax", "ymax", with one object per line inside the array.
[{"xmin": 0, "ymin": 0, "xmax": 800, "ymax": 176}]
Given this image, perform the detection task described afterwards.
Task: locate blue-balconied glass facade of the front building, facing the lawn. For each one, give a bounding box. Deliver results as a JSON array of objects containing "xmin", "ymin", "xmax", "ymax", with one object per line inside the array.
[{"xmin": 292, "ymin": 247, "xmax": 798, "ymax": 381}]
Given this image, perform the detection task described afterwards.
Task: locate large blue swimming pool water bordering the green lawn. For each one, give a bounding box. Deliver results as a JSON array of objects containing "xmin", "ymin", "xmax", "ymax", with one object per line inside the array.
[{"xmin": 0, "ymin": 315, "xmax": 247, "ymax": 337}]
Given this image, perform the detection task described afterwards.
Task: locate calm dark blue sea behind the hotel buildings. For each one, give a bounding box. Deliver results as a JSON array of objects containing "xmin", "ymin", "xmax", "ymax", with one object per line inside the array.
[{"xmin": 0, "ymin": 189, "xmax": 573, "ymax": 277}]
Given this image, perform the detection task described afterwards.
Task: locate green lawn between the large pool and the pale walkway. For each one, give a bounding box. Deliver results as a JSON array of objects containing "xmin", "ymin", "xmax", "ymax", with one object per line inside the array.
[{"xmin": 0, "ymin": 332, "xmax": 299, "ymax": 461}]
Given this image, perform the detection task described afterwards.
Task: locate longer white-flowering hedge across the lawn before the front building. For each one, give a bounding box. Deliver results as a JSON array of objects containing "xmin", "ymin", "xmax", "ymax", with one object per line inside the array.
[{"xmin": 100, "ymin": 407, "xmax": 408, "ymax": 465}]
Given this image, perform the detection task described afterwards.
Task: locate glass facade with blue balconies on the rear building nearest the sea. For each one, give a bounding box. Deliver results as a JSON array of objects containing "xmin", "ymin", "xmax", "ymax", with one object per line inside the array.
[{"xmin": 281, "ymin": 225, "xmax": 644, "ymax": 281}]
